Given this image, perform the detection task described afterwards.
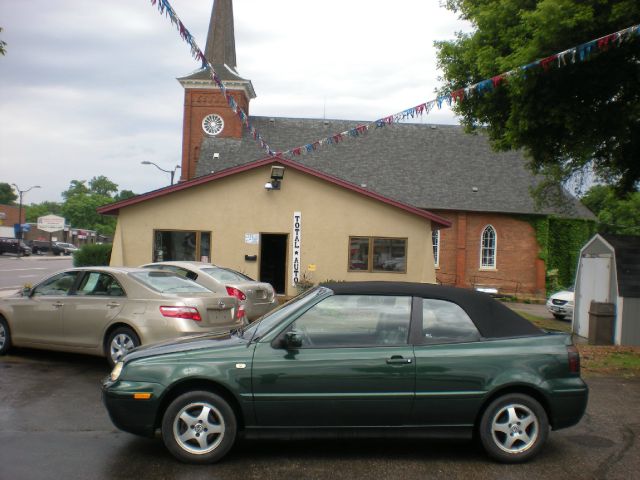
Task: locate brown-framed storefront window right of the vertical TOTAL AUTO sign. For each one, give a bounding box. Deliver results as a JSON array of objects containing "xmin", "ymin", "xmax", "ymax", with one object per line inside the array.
[{"xmin": 349, "ymin": 237, "xmax": 407, "ymax": 273}]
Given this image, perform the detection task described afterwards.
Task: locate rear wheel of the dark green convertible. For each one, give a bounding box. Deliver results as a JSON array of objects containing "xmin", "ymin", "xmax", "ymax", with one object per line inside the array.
[{"xmin": 479, "ymin": 394, "xmax": 549, "ymax": 463}]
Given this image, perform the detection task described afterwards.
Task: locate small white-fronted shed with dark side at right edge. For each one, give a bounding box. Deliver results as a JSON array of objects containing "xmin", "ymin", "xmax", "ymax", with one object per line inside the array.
[{"xmin": 572, "ymin": 234, "xmax": 640, "ymax": 345}]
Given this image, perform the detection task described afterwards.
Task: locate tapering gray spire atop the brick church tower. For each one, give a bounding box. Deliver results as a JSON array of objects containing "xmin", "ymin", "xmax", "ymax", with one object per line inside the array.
[{"xmin": 204, "ymin": 0, "xmax": 237, "ymax": 70}]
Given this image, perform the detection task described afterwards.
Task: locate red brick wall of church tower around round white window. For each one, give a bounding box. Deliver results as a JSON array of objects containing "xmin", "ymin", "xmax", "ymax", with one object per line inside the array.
[{"xmin": 180, "ymin": 89, "xmax": 249, "ymax": 180}]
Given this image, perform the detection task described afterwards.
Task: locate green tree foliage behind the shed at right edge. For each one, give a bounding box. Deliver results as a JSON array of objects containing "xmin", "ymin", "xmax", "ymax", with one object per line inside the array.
[{"xmin": 581, "ymin": 185, "xmax": 640, "ymax": 235}]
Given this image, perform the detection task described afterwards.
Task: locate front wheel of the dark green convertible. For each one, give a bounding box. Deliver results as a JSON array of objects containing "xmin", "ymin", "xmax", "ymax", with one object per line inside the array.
[{"xmin": 162, "ymin": 391, "xmax": 237, "ymax": 464}]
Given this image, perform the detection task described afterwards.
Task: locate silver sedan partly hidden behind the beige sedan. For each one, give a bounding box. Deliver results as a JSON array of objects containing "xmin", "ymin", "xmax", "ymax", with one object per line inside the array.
[{"xmin": 143, "ymin": 261, "xmax": 278, "ymax": 321}]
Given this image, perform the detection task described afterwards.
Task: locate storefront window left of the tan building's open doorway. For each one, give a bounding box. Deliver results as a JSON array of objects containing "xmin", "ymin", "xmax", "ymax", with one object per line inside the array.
[{"xmin": 153, "ymin": 230, "xmax": 211, "ymax": 262}]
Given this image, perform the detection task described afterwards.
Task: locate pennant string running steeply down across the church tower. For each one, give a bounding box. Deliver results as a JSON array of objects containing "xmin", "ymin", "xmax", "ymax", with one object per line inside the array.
[{"xmin": 151, "ymin": 0, "xmax": 275, "ymax": 156}]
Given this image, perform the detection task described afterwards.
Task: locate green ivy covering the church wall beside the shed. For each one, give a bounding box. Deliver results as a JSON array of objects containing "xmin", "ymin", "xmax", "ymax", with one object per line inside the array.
[{"xmin": 528, "ymin": 217, "xmax": 596, "ymax": 293}]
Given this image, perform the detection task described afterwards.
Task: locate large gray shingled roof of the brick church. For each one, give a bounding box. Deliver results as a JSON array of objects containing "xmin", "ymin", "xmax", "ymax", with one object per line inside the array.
[{"xmin": 197, "ymin": 117, "xmax": 594, "ymax": 218}]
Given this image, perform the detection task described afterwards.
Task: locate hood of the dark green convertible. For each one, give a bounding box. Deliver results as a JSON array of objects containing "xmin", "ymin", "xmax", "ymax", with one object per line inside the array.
[{"xmin": 124, "ymin": 333, "xmax": 247, "ymax": 363}]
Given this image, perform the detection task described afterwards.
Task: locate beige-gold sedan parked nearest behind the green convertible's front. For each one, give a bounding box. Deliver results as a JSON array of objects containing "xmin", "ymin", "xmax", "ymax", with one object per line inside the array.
[{"xmin": 0, "ymin": 267, "xmax": 244, "ymax": 365}]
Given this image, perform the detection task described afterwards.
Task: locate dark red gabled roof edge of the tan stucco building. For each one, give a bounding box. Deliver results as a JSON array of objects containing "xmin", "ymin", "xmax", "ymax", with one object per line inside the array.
[{"xmin": 98, "ymin": 156, "xmax": 451, "ymax": 228}]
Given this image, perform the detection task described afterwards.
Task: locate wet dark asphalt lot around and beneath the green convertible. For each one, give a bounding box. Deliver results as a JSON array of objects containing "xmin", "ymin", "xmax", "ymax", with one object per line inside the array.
[{"xmin": 0, "ymin": 349, "xmax": 640, "ymax": 480}]
